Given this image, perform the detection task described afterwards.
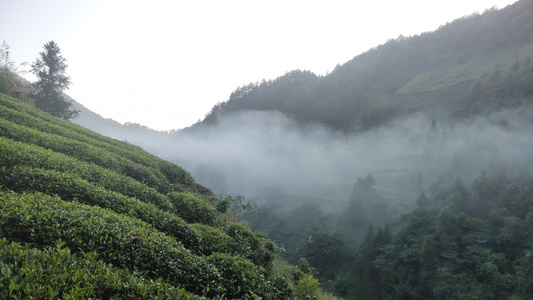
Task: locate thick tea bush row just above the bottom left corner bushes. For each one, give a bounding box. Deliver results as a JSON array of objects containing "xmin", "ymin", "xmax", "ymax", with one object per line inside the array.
[{"xmin": 0, "ymin": 192, "xmax": 288, "ymax": 299}]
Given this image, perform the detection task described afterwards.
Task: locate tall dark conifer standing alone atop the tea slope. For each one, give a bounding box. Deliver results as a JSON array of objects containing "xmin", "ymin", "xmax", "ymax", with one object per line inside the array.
[{"xmin": 31, "ymin": 41, "xmax": 78, "ymax": 120}]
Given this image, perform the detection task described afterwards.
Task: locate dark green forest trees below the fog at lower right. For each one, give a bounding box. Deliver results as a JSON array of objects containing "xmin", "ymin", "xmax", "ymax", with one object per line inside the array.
[{"xmin": 359, "ymin": 173, "xmax": 533, "ymax": 299}]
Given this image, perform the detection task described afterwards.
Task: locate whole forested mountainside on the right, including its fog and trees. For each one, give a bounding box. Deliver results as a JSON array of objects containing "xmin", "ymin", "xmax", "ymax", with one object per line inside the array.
[{"xmin": 153, "ymin": 0, "xmax": 533, "ymax": 299}]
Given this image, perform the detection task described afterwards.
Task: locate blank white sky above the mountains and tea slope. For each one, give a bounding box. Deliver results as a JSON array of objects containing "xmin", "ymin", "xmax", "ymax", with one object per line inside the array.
[{"xmin": 0, "ymin": 0, "xmax": 516, "ymax": 130}]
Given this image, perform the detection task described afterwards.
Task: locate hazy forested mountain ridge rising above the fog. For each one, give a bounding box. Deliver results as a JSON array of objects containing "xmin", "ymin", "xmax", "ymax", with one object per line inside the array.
[{"xmin": 193, "ymin": 0, "xmax": 533, "ymax": 132}]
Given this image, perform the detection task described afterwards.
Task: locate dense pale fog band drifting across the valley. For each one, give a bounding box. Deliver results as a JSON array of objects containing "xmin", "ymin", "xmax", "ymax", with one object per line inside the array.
[{"xmin": 151, "ymin": 111, "xmax": 533, "ymax": 205}]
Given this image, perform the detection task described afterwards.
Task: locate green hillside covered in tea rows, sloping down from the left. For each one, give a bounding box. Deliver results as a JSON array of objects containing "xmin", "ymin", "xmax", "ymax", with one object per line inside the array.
[{"xmin": 0, "ymin": 94, "xmax": 328, "ymax": 299}]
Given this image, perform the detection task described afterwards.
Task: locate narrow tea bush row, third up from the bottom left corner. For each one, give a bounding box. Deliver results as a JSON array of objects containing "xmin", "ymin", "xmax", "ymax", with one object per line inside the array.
[{"xmin": 0, "ymin": 165, "xmax": 275, "ymax": 269}]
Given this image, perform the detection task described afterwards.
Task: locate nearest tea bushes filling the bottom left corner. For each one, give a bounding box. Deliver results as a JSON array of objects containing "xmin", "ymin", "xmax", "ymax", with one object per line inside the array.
[{"xmin": 0, "ymin": 238, "xmax": 199, "ymax": 300}]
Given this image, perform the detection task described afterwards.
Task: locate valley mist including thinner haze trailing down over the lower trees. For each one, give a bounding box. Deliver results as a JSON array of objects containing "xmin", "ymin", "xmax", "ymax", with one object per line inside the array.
[{"xmin": 103, "ymin": 106, "xmax": 533, "ymax": 263}]
